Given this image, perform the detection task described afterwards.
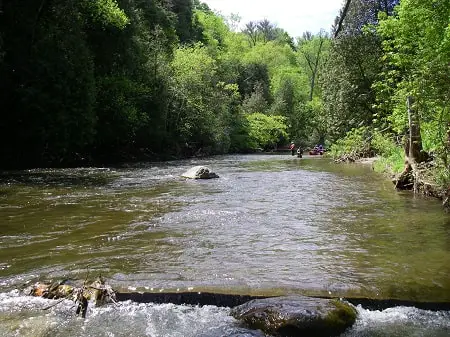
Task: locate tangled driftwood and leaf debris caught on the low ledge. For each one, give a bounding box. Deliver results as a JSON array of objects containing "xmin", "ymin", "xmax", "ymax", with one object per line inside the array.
[{"xmin": 25, "ymin": 277, "xmax": 117, "ymax": 318}]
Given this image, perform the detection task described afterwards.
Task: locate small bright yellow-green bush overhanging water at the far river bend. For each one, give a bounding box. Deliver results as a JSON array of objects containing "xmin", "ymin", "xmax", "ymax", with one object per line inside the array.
[{"xmin": 247, "ymin": 112, "xmax": 288, "ymax": 150}]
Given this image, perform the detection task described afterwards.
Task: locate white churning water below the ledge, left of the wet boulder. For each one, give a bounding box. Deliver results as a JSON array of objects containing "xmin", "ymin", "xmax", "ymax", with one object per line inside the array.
[{"xmin": 0, "ymin": 291, "xmax": 260, "ymax": 337}]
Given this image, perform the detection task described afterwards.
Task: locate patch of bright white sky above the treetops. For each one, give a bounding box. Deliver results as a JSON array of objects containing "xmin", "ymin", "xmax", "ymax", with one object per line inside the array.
[{"xmin": 201, "ymin": 0, "xmax": 344, "ymax": 38}]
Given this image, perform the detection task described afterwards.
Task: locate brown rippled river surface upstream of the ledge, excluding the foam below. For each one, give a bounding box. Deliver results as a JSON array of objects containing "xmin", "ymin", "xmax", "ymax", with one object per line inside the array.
[{"xmin": 0, "ymin": 155, "xmax": 450, "ymax": 298}]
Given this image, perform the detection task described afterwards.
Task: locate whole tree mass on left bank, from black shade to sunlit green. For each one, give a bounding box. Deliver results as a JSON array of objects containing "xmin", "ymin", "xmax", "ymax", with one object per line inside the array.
[{"xmin": 0, "ymin": 0, "xmax": 324, "ymax": 167}]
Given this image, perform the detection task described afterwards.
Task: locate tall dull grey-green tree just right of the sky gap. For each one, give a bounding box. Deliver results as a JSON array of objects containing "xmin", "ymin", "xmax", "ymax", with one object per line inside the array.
[{"xmin": 322, "ymin": 0, "xmax": 397, "ymax": 139}]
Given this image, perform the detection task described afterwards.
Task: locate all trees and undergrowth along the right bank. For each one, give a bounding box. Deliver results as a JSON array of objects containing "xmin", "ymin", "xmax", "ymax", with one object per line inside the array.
[{"xmin": 323, "ymin": 0, "xmax": 450, "ymax": 194}]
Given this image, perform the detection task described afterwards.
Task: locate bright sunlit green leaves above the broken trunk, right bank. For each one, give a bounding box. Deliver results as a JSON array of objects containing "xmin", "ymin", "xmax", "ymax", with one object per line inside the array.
[{"xmin": 376, "ymin": 0, "xmax": 450, "ymax": 143}]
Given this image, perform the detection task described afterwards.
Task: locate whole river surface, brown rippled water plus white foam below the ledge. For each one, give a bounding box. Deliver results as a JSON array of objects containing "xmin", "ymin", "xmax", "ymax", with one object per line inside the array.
[{"xmin": 0, "ymin": 155, "xmax": 450, "ymax": 337}]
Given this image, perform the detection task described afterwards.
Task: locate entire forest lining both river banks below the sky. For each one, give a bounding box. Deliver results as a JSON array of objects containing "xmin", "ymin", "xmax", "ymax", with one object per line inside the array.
[{"xmin": 0, "ymin": 0, "xmax": 450, "ymax": 190}]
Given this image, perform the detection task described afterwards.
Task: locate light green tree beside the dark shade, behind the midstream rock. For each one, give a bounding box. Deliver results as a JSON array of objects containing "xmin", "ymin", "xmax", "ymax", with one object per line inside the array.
[{"xmin": 170, "ymin": 44, "xmax": 237, "ymax": 152}]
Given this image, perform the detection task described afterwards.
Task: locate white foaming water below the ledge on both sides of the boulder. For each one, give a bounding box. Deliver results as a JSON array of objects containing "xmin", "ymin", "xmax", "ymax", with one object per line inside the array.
[{"xmin": 0, "ymin": 290, "xmax": 450, "ymax": 337}]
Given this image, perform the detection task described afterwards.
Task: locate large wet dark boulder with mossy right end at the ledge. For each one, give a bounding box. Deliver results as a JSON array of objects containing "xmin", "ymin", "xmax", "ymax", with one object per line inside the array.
[{"xmin": 231, "ymin": 296, "xmax": 356, "ymax": 337}]
